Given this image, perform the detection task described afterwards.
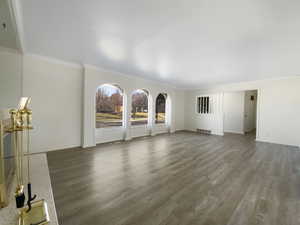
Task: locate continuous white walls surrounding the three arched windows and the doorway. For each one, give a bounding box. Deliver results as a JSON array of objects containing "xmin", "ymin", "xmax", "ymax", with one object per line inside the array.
[{"xmin": 6, "ymin": 50, "xmax": 300, "ymax": 152}]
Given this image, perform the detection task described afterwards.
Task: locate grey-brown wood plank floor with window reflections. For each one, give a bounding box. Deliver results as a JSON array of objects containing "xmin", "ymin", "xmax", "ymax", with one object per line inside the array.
[{"xmin": 48, "ymin": 132, "xmax": 300, "ymax": 225}]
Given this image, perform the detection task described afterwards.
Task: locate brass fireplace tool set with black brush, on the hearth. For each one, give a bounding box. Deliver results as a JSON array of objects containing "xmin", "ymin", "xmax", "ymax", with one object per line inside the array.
[{"xmin": 9, "ymin": 98, "xmax": 50, "ymax": 225}]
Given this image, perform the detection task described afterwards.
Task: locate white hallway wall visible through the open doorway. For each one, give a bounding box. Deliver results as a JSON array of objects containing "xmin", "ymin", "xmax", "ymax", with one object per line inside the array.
[{"xmin": 223, "ymin": 91, "xmax": 245, "ymax": 134}]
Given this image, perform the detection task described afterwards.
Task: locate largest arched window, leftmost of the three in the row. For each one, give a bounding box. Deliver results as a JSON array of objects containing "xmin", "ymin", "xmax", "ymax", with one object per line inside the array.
[{"xmin": 96, "ymin": 84, "xmax": 123, "ymax": 128}]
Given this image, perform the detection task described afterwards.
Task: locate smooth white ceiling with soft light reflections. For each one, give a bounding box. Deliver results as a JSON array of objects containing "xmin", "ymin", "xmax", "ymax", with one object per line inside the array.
[{"xmin": 22, "ymin": 0, "xmax": 300, "ymax": 88}]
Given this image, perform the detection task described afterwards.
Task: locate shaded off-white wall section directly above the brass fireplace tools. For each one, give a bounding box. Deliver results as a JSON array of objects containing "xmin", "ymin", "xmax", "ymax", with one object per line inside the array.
[{"xmin": 0, "ymin": 47, "xmax": 22, "ymax": 109}]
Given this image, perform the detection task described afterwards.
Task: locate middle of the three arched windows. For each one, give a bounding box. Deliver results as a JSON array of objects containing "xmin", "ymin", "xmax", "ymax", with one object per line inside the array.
[{"xmin": 130, "ymin": 90, "xmax": 148, "ymax": 125}]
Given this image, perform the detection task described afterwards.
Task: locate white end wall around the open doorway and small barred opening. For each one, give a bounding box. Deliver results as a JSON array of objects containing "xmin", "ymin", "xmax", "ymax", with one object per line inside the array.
[{"xmin": 185, "ymin": 76, "xmax": 300, "ymax": 146}]
